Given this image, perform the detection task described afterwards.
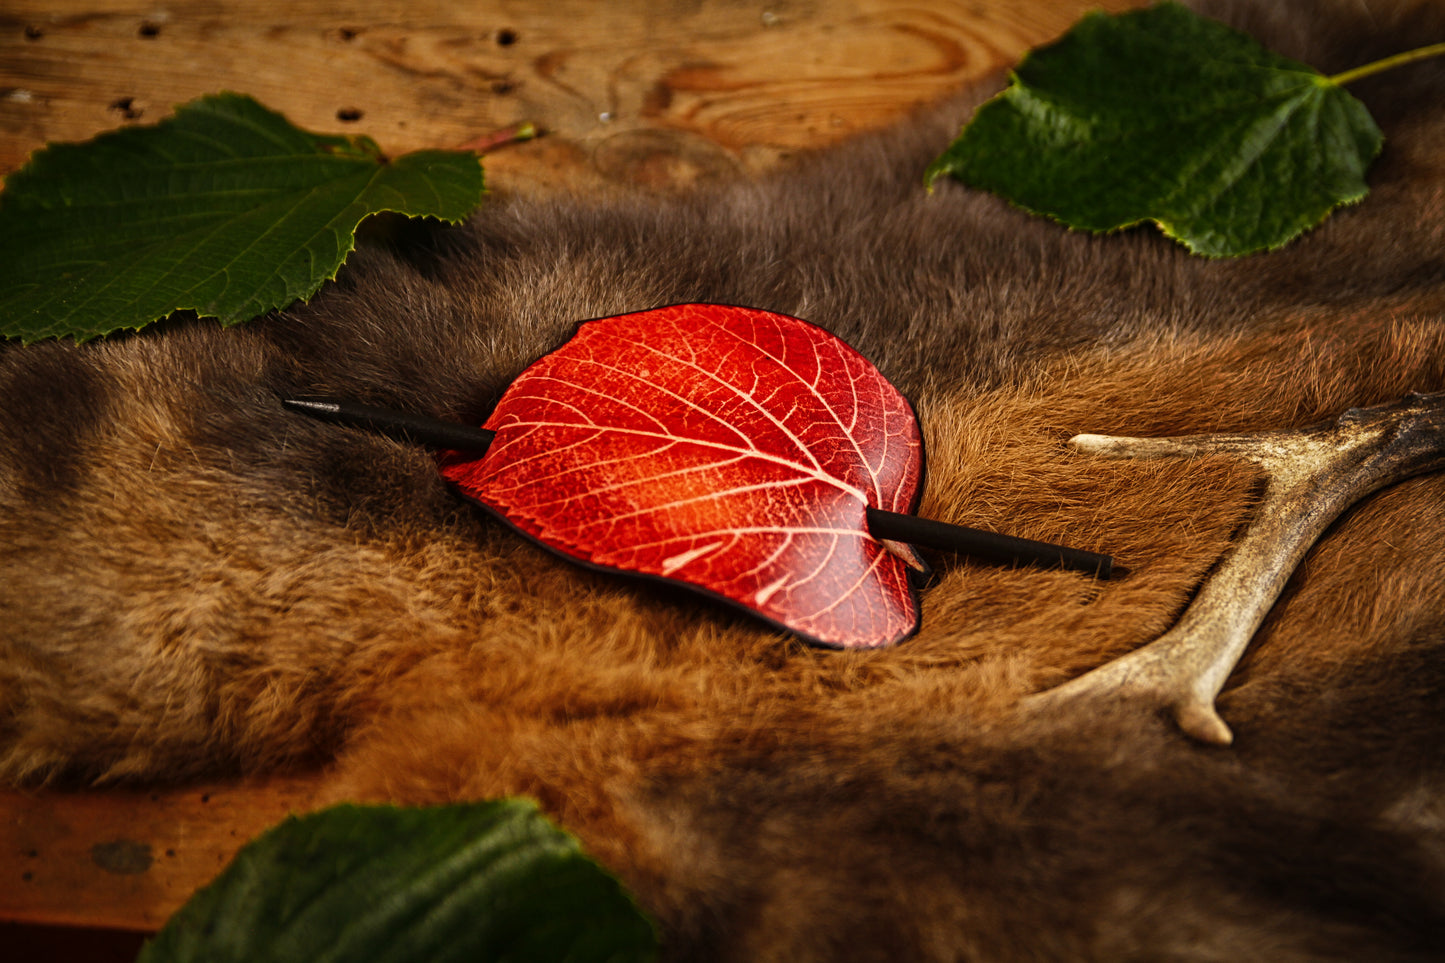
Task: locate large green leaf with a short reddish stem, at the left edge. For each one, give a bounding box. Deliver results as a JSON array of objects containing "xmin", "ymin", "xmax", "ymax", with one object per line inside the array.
[{"xmin": 0, "ymin": 94, "xmax": 483, "ymax": 341}]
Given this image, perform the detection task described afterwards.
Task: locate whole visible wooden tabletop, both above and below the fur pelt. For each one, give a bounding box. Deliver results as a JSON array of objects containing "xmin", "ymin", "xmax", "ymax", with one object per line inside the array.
[{"xmin": 0, "ymin": 0, "xmax": 1129, "ymax": 930}]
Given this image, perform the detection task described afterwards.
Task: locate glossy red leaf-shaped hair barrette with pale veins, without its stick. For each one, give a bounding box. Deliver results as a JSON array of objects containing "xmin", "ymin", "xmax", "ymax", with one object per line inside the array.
[{"xmin": 442, "ymin": 304, "xmax": 922, "ymax": 648}]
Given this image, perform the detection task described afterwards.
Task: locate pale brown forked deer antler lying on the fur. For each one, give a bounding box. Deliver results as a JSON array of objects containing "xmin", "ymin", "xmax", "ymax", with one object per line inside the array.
[{"xmin": 1027, "ymin": 393, "xmax": 1445, "ymax": 745}]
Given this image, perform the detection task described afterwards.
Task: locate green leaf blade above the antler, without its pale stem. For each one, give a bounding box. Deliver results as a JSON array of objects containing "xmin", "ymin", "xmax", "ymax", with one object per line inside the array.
[{"xmin": 926, "ymin": 3, "xmax": 1381, "ymax": 257}]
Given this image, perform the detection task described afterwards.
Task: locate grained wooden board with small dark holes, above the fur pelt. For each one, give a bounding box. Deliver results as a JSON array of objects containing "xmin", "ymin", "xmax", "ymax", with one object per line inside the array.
[{"xmin": 0, "ymin": 0, "xmax": 1130, "ymax": 190}]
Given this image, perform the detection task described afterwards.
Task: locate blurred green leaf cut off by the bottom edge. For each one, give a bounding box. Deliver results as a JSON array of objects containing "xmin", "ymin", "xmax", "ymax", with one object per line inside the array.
[{"xmin": 137, "ymin": 800, "xmax": 657, "ymax": 963}]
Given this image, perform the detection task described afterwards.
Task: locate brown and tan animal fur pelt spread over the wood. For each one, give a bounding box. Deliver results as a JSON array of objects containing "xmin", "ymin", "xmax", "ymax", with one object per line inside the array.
[{"xmin": 0, "ymin": 0, "xmax": 1445, "ymax": 960}]
